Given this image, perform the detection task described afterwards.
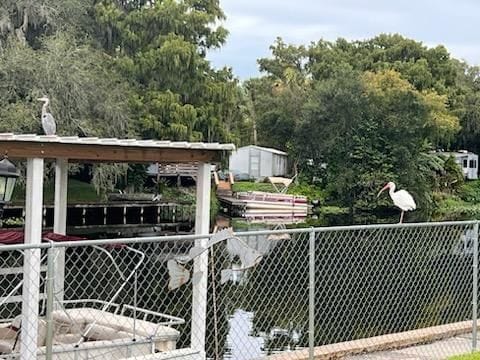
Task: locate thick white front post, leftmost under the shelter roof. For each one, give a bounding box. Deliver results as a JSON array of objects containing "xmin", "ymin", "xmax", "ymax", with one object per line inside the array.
[{"xmin": 20, "ymin": 159, "xmax": 43, "ymax": 360}]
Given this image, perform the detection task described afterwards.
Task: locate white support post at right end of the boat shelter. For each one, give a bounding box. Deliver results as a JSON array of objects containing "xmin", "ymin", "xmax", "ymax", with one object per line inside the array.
[{"xmin": 191, "ymin": 164, "xmax": 211, "ymax": 358}]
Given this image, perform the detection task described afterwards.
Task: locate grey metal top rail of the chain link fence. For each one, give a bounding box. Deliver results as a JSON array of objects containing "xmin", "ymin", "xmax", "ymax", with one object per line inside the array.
[{"xmin": 0, "ymin": 220, "xmax": 480, "ymax": 252}]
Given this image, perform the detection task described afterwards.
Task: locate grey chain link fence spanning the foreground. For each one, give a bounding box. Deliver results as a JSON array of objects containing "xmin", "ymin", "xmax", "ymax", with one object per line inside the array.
[{"xmin": 0, "ymin": 222, "xmax": 478, "ymax": 360}]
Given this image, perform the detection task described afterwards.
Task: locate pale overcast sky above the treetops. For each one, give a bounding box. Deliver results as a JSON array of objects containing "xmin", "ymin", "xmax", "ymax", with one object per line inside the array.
[{"xmin": 208, "ymin": 0, "xmax": 480, "ymax": 79}]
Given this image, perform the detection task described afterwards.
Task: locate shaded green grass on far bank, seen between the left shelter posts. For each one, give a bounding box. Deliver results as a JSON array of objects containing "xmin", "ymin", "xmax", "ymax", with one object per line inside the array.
[{"xmin": 12, "ymin": 179, "xmax": 100, "ymax": 204}]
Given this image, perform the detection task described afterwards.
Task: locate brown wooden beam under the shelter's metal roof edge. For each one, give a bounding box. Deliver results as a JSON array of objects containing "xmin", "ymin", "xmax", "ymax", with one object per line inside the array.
[{"xmin": 0, "ymin": 141, "xmax": 222, "ymax": 163}]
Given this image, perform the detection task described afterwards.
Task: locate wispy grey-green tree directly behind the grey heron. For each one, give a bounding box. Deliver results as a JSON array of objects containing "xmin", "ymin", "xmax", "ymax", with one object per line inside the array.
[{"xmin": 0, "ymin": 33, "xmax": 131, "ymax": 137}]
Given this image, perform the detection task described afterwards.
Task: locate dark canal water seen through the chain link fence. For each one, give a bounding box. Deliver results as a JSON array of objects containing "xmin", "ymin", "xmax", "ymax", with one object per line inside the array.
[{"xmin": 54, "ymin": 211, "xmax": 471, "ymax": 360}]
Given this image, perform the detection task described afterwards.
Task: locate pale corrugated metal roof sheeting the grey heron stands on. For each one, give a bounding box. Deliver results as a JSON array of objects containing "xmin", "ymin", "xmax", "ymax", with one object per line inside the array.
[{"xmin": 0, "ymin": 133, "xmax": 235, "ymax": 151}]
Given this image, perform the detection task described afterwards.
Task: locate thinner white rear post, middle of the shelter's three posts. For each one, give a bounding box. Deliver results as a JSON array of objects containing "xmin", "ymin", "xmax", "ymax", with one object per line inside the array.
[{"xmin": 53, "ymin": 159, "xmax": 68, "ymax": 301}]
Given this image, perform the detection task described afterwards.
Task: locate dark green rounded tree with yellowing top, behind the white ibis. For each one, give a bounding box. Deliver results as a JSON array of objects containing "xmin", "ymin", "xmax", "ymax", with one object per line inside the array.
[{"xmin": 297, "ymin": 70, "xmax": 458, "ymax": 210}]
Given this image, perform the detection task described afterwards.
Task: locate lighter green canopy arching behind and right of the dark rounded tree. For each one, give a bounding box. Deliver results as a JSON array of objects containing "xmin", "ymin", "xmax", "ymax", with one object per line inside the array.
[{"xmin": 307, "ymin": 34, "xmax": 464, "ymax": 148}]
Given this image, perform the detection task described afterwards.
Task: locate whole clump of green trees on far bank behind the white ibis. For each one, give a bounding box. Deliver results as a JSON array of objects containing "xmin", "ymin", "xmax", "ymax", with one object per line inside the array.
[{"xmin": 255, "ymin": 34, "xmax": 468, "ymax": 210}]
